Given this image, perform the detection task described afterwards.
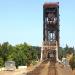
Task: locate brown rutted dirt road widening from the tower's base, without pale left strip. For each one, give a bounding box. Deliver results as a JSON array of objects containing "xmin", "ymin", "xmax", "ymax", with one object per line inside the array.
[{"xmin": 27, "ymin": 61, "xmax": 73, "ymax": 75}]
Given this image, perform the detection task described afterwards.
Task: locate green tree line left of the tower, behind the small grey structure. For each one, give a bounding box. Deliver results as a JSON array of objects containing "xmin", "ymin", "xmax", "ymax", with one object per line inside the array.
[{"xmin": 0, "ymin": 42, "xmax": 40, "ymax": 67}]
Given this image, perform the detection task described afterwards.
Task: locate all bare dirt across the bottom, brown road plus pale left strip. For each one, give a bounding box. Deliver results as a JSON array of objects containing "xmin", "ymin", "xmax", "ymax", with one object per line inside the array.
[{"xmin": 0, "ymin": 61, "xmax": 75, "ymax": 75}]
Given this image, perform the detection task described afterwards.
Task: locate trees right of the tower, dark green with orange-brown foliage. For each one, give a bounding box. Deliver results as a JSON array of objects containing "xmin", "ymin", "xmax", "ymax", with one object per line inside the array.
[{"xmin": 58, "ymin": 44, "xmax": 75, "ymax": 69}]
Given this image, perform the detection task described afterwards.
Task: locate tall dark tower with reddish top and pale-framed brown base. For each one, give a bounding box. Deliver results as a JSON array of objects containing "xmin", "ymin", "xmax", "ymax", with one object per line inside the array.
[{"xmin": 41, "ymin": 2, "xmax": 59, "ymax": 61}]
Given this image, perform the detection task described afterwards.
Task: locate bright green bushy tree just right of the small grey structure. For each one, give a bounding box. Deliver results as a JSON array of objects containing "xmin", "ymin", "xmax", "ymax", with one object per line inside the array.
[{"xmin": 14, "ymin": 43, "xmax": 32, "ymax": 66}]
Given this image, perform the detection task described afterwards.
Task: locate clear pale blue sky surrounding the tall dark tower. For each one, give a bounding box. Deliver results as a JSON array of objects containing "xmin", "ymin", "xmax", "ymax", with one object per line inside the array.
[{"xmin": 0, "ymin": 0, "xmax": 75, "ymax": 47}]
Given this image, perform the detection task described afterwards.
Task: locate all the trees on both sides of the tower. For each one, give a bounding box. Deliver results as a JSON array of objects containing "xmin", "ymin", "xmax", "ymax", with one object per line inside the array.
[{"xmin": 0, "ymin": 42, "xmax": 75, "ymax": 68}]
